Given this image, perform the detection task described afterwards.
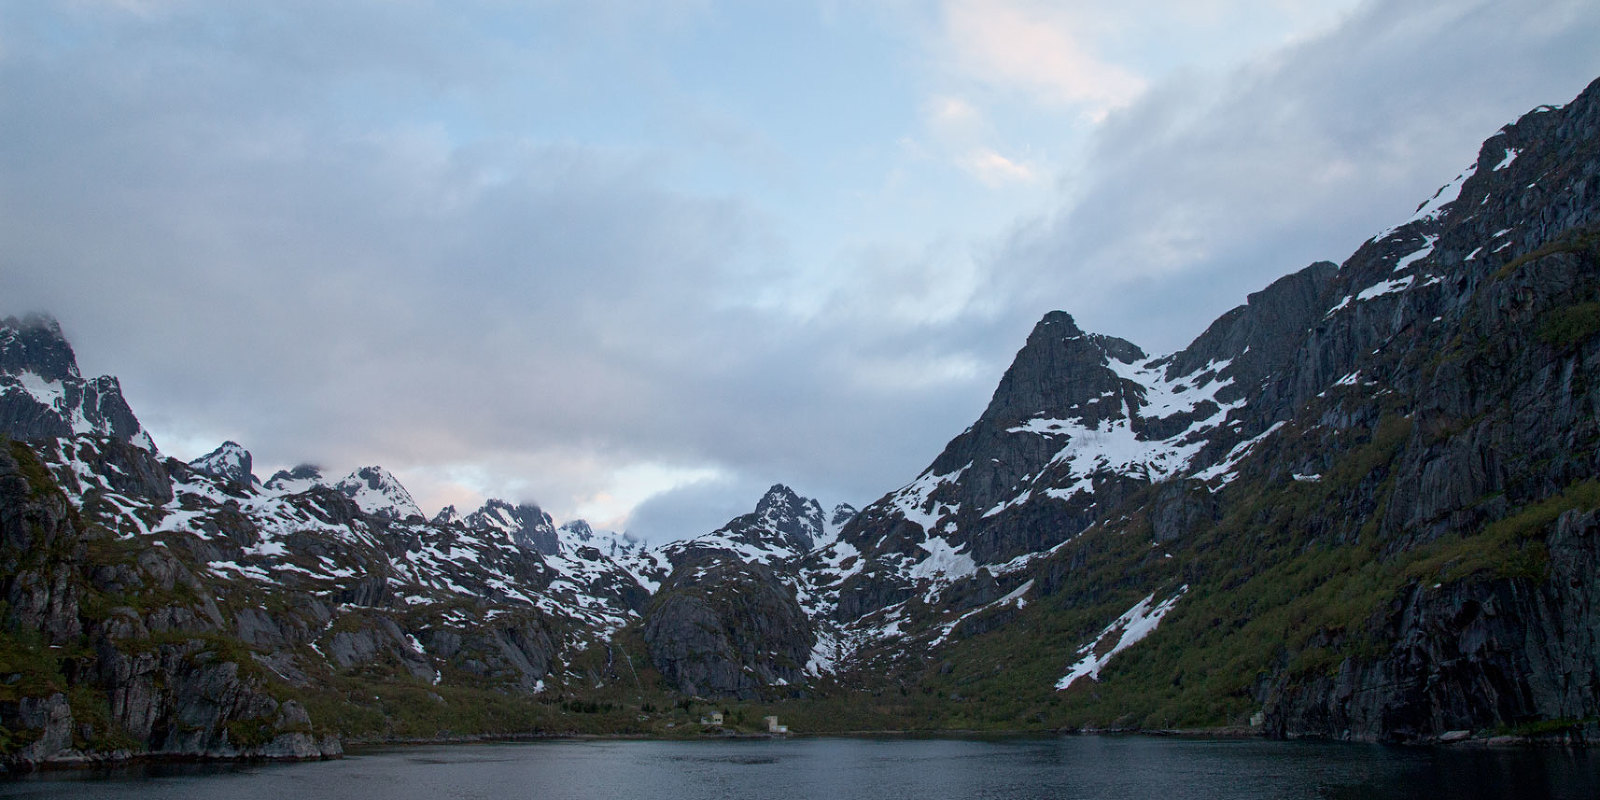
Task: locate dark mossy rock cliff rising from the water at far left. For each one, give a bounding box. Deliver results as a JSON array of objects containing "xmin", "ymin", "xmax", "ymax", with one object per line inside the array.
[{"xmin": 0, "ymin": 443, "xmax": 339, "ymax": 765}]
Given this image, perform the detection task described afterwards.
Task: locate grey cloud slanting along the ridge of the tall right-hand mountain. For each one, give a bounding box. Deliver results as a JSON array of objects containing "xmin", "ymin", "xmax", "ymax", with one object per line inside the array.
[{"xmin": 995, "ymin": 0, "xmax": 1600, "ymax": 350}]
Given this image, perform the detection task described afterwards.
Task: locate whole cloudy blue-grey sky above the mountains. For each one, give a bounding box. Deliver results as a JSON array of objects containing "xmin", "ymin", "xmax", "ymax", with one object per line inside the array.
[{"xmin": 0, "ymin": 0, "xmax": 1600, "ymax": 542}]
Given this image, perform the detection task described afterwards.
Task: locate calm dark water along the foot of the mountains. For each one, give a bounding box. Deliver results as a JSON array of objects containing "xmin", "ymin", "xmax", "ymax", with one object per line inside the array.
[{"xmin": 0, "ymin": 736, "xmax": 1600, "ymax": 800}]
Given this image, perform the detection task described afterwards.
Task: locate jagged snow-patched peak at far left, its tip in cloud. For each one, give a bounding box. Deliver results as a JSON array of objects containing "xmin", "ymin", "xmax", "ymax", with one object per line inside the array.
[{"xmin": 0, "ymin": 315, "xmax": 155, "ymax": 450}]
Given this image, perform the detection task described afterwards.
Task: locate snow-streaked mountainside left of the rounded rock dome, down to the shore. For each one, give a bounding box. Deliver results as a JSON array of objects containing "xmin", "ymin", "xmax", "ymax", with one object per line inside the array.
[{"xmin": 0, "ymin": 318, "xmax": 661, "ymax": 763}]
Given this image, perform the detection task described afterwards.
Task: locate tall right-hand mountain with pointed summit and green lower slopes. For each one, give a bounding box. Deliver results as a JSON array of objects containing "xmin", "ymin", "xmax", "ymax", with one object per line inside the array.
[{"xmin": 806, "ymin": 75, "xmax": 1600, "ymax": 741}]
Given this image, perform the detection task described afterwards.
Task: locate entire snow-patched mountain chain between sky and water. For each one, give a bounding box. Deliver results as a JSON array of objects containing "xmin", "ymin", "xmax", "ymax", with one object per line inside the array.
[{"xmin": 0, "ymin": 82, "xmax": 1600, "ymax": 766}]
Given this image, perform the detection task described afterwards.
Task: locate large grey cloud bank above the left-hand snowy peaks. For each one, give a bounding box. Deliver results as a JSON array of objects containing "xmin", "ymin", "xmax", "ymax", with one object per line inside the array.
[{"xmin": 0, "ymin": 6, "xmax": 995, "ymax": 523}]
